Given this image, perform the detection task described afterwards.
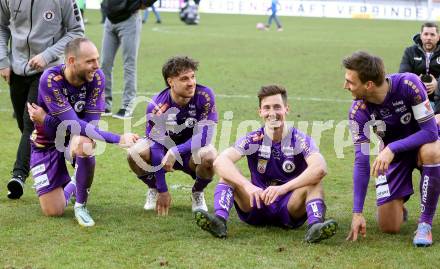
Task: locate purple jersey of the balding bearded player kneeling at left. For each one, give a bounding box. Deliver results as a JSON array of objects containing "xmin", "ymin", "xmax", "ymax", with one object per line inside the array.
[{"xmin": 31, "ymin": 64, "xmax": 105, "ymax": 148}]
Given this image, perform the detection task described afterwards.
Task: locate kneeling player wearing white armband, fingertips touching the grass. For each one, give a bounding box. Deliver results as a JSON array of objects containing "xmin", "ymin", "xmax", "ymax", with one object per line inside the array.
[{"xmin": 343, "ymin": 52, "xmax": 440, "ymax": 247}]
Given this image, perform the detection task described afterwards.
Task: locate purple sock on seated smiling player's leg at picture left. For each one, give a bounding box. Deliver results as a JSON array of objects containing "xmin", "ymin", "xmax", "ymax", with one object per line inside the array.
[{"xmin": 214, "ymin": 183, "xmax": 234, "ymax": 220}]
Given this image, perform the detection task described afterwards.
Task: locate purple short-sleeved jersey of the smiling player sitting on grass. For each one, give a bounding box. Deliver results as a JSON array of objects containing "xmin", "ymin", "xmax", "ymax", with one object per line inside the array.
[{"xmin": 235, "ymin": 127, "xmax": 319, "ymax": 189}]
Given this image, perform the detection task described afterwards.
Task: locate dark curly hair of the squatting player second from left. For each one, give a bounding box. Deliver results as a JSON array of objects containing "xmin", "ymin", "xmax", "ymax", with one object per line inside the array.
[{"xmin": 162, "ymin": 56, "xmax": 199, "ymax": 86}]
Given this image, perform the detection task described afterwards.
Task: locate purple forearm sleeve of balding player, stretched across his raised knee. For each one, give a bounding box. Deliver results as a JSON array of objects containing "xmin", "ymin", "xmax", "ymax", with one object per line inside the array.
[{"xmin": 56, "ymin": 109, "xmax": 121, "ymax": 144}]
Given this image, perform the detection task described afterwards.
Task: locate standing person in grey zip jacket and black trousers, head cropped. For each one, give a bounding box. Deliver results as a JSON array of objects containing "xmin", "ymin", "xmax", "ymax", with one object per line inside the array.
[{"xmin": 0, "ymin": 0, "xmax": 84, "ymax": 199}]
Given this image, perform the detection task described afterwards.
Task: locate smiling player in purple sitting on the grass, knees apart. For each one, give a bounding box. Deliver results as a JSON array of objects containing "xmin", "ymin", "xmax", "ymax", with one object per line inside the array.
[{"xmin": 195, "ymin": 85, "xmax": 338, "ymax": 243}]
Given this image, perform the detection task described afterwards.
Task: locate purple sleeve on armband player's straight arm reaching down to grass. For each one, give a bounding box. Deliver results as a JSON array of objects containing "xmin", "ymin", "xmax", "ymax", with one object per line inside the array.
[{"xmin": 353, "ymin": 143, "xmax": 370, "ymax": 213}]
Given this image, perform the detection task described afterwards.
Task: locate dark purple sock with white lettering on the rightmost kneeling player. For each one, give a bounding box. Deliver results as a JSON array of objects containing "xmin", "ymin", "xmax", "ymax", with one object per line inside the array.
[{"xmin": 419, "ymin": 164, "xmax": 440, "ymax": 225}]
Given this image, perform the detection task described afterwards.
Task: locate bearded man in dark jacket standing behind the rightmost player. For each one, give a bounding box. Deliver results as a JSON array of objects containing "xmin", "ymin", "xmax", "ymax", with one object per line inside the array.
[{"xmin": 399, "ymin": 22, "xmax": 440, "ymax": 114}]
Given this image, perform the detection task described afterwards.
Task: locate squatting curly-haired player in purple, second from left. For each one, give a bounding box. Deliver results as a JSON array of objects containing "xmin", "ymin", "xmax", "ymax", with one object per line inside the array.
[{"xmin": 128, "ymin": 56, "xmax": 218, "ymax": 215}]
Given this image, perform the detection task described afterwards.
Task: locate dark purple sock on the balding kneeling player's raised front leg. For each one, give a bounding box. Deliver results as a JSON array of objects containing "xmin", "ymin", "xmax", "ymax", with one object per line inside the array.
[{"xmin": 76, "ymin": 156, "xmax": 95, "ymax": 204}]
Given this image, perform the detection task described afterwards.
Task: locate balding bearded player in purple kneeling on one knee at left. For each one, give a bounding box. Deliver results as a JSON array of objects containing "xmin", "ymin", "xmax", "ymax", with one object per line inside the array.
[{"xmin": 28, "ymin": 38, "xmax": 138, "ymax": 227}]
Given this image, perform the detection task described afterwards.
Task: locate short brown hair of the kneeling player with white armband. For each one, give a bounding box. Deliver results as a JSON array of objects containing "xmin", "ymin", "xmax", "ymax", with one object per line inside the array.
[{"xmin": 342, "ymin": 51, "xmax": 385, "ymax": 86}]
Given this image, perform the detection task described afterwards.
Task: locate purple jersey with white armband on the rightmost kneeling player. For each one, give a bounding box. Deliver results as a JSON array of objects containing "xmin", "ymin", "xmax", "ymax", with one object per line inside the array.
[{"xmin": 349, "ymin": 73, "xmax": 434, "ymax": 146}]
